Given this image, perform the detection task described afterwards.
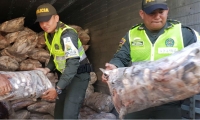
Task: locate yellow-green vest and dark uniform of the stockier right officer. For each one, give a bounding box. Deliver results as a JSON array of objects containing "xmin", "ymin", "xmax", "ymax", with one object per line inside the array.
[{"xmin": 110, "ymin": 20, "xmax": 198, "ymax": 119}]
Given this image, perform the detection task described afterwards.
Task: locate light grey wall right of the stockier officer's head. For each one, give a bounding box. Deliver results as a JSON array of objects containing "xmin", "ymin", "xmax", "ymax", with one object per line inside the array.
[{"xmin": 168, "ymin": 0, "xmax": 200, "ymax": 32}]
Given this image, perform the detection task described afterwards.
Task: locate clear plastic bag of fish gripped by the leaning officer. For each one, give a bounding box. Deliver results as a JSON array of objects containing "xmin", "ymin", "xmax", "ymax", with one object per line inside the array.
[{"xmin": 0, "ymin": 70, "xmax": 52, "ymax": 101}]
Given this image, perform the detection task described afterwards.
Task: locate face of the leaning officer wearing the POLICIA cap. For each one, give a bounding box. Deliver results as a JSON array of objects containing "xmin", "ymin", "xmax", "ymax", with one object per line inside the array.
[{"xmin": 39, "ymin": 15, "xmax": 59, "ymax": 33}]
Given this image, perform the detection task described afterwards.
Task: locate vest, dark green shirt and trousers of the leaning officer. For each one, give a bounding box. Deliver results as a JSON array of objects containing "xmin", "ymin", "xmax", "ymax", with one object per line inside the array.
[{"xmin": 45, "ymin": 22, "xmax": 90, "ymax": 119}]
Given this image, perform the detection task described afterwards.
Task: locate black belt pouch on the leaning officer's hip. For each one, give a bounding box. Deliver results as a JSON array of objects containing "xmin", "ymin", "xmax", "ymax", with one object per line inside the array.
[{"xmin": 77, "ymin": 63, "xmax": 93, "ymax": 74}]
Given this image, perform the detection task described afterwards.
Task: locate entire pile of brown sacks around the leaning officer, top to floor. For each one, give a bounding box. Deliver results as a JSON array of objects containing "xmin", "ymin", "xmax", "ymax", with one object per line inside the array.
[{"xmin": 0, "ymin": 17, "xmax": 116, "ymax": 119}]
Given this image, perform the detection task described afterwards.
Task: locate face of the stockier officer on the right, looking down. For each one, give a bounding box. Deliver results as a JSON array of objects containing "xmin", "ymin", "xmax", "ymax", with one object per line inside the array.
[{"xmin": 140, "ymin": 9, "xmax": 169, "ymax": 32}]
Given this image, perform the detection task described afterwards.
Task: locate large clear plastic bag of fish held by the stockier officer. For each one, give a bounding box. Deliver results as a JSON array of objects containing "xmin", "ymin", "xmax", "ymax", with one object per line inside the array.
[{"xmin": 101, "ymin": 42, "xmax": 200, "ymax": 118}]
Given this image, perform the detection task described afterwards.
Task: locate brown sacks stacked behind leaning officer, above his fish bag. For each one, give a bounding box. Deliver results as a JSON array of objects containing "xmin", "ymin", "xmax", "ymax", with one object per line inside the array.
[{"xmin": 0, "ymin": 17, "xmax": 90, "ymax": 71}]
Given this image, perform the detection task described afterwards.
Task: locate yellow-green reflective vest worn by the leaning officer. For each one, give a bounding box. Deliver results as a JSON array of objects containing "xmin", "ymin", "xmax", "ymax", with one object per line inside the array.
[{"xmin": 45, "ymin": 22, "xmax": 86, "ymax": 73}]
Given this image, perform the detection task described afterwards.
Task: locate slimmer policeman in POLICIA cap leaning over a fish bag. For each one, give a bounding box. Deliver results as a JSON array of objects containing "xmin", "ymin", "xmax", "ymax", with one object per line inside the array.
[{"xmin": 36, "ymin": 3, "xmax": 90, "ymax": 119}]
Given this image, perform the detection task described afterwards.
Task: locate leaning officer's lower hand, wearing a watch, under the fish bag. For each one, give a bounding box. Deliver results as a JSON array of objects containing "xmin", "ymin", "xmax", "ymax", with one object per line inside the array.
[{"xmin": 41, "ymin": 88, "xmax": 58, "ymax": 101}]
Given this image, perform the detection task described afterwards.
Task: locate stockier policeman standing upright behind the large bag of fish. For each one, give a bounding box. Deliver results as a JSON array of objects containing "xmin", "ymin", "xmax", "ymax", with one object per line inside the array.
[{"xmin": 102, "ymin": 0, "xmax": 198, "ymax": 119}]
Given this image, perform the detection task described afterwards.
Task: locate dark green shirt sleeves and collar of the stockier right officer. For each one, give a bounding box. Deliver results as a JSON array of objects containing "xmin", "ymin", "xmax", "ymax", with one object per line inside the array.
[{"xmin": 110, "ymin": 21, "xmax": 197, "ymax": 67}]
